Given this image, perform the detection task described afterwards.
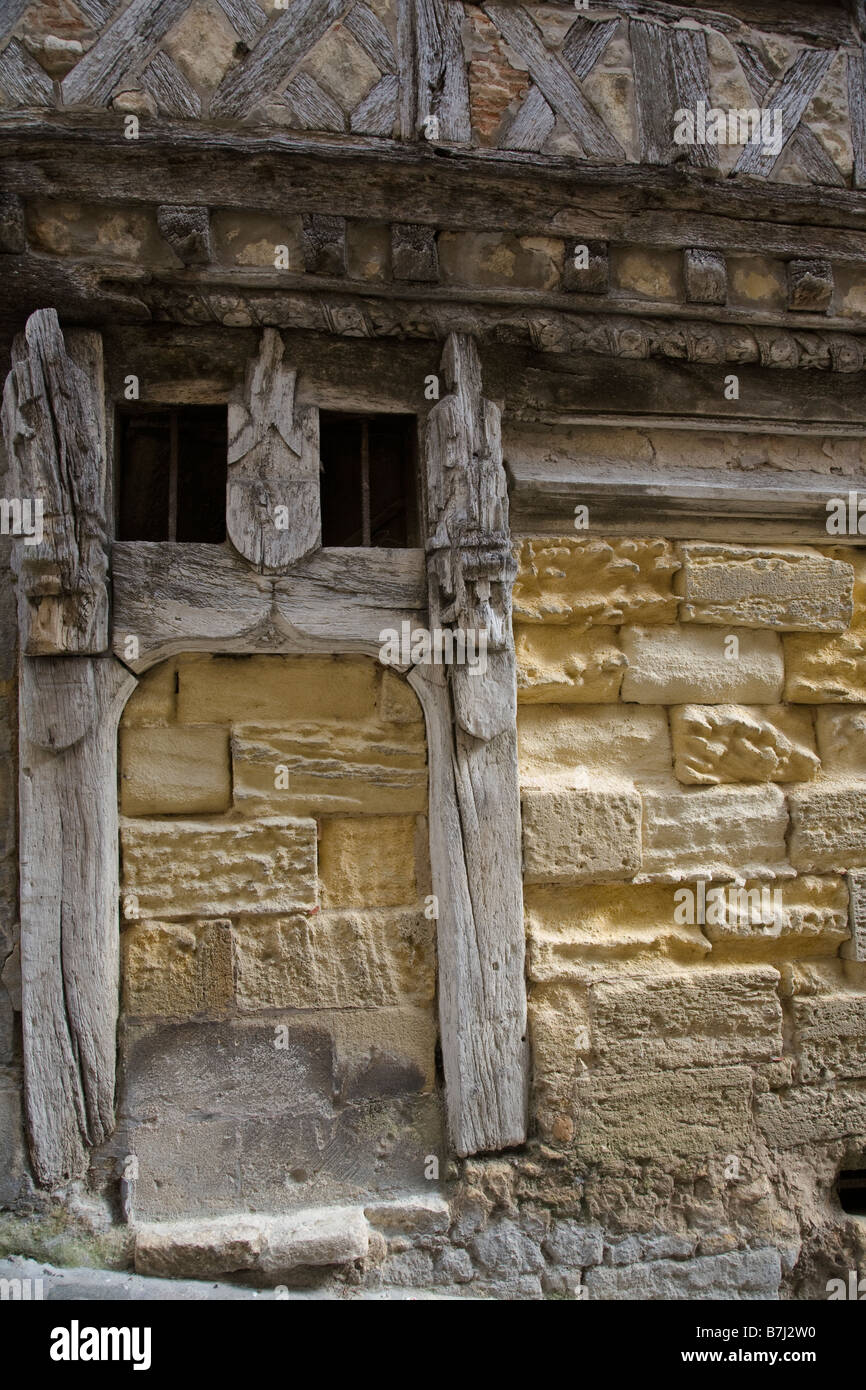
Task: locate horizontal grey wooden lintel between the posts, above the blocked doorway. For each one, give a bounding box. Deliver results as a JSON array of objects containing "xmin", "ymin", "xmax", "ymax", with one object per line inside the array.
[{"xmin": 111, "ymin": 541, "xmax": 427, "ymax": 671}]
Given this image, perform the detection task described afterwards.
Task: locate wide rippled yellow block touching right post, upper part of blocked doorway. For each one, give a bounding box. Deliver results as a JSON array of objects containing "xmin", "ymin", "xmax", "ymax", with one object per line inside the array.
[{"xmin": 232, "ymin": 722, "xmax": 427, "ymax": 816}]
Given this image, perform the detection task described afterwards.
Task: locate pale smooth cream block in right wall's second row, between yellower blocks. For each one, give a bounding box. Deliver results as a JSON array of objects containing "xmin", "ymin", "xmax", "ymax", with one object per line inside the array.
[{"xmin": 620, "ymin": 624, "xmax": 784, "ymax": 705}]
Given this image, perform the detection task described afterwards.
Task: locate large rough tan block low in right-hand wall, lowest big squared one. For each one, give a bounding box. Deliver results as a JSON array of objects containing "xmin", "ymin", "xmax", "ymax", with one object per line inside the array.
[{"xmin": 588, "ymin": 966, "xmax": 783, "ymax": 1076}]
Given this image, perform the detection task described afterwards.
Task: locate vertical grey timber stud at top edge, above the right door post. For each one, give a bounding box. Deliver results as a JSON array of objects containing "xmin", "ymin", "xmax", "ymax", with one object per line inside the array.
[{"xmin": 414, "ymin": 0, "xmax": 473, "ymax": 143}]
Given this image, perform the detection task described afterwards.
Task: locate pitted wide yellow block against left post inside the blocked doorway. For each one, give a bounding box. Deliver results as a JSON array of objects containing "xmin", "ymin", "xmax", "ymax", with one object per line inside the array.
[{"xmin": 121, "ymin": 817, "xmax": 317, "ymax": 920}]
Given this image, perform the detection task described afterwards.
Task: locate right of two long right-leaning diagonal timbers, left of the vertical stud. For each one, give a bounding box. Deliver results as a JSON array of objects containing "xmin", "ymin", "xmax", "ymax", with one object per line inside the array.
[{"xmin": 210, "ymin": 0, "xmax": 346, "ymax": 117}]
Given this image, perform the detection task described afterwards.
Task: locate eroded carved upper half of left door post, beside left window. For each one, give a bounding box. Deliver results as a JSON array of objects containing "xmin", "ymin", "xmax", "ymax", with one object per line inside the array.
[{"xmin": 3, "ymin": 309, "xmax": 108, "ymax": 656}]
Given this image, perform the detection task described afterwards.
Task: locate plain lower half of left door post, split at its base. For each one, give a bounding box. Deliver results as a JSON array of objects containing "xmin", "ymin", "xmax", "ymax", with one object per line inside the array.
[{"xmin": 18, "ymin": 656, "xmax": 136, "ymax": 1187}]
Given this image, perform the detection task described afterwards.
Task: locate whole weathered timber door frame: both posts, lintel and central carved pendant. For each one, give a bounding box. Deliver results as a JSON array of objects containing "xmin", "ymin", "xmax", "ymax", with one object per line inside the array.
[{"xmin": 4, "ymin": 310, "xmax": 528, "ymax": 1187}]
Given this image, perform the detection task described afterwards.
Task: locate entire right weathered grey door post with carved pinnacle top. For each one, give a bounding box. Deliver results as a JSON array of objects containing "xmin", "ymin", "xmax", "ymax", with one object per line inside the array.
[{"xmin": 411, "ymin": 334, "xmax": 528, "ymax": 1155}]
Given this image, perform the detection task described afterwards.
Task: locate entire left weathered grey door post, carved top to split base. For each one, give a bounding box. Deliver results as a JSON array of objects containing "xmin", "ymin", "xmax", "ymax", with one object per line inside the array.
[{"xmin": 3, "ymin": 310, "xmax": 135, "ymax": 1186}]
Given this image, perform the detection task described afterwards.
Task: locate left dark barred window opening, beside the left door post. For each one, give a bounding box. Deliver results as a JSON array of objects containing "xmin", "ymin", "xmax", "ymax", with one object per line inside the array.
[{"xmin": 117, "ymin": 406, "xmax": 228, "ymax": 543}]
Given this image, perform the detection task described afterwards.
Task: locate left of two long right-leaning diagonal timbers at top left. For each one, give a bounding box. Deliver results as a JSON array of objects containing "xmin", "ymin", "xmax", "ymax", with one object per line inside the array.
[{"xmin": 61, "ymin": 0, "xmax": 189, "ymax": 106}]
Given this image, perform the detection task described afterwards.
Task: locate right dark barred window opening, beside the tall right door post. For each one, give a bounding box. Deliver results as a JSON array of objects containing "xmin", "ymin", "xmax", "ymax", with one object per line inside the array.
[{"xmin": 318, "ymin": 410, "xmax": 418, "ymax": 548}]
